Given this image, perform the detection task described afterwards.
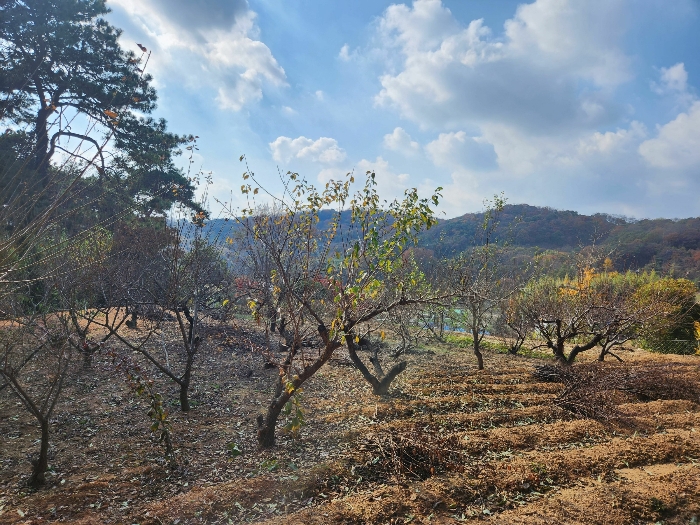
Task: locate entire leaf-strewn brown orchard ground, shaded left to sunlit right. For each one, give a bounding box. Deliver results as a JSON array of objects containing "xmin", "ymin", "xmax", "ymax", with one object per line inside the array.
[{"xmin": 0, "ymin": 322, "xmax": 700, "ymax": 525}]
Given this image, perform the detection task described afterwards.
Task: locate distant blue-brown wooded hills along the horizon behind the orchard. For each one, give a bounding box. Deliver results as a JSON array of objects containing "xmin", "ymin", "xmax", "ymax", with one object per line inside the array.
[{"xmin": 191, "ymin": 204, "xmax": 700, "ymax": 282}]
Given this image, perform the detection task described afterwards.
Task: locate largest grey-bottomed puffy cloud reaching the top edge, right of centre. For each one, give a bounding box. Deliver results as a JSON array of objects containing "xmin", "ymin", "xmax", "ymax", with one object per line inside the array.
[{"xmin": 375, "ymin": 0, "xmax": 631, "ymax": 134}]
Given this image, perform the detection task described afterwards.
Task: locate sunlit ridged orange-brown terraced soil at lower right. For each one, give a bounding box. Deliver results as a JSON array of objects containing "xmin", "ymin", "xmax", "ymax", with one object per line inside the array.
[{"xmin": 253, "ymin": 356, "xmax": 700, "ymax": 524}]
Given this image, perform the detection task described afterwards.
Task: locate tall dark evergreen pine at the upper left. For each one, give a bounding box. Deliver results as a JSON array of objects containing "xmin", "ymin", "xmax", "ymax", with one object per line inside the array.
[{"xmin": 0, "ymin": 0, "xmax": 200, "ymax": 216}]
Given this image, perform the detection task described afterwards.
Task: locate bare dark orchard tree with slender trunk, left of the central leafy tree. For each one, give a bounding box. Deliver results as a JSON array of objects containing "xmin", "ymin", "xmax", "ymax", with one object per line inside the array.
[{"xmin": 81, "ymin": 212, "xmax": 231, "ymax": 412}]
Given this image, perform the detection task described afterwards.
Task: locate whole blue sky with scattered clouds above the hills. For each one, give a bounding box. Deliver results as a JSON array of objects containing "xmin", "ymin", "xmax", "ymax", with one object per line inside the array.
[{"xmin": 108, "ymin": 0, "xmax": 700, "ymax": 218}]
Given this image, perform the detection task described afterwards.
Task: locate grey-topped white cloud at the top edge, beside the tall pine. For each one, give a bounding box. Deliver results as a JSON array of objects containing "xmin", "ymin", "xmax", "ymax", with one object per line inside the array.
[{"xmin": 110, "ymin": 0, "xmax": 286, "ymax": 111}]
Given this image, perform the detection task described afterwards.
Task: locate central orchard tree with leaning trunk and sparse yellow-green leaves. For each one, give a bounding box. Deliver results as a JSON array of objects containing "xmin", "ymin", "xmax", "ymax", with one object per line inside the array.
[{"xmin": 227, "ymin": 165, "xmax": 439, "ymax": 447}]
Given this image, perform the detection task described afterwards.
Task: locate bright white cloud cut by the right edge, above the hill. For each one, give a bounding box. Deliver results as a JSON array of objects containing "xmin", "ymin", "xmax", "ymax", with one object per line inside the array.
[{"xmin": 639, "ymin": 101, "xmax": 700, "ymax": 169}]
